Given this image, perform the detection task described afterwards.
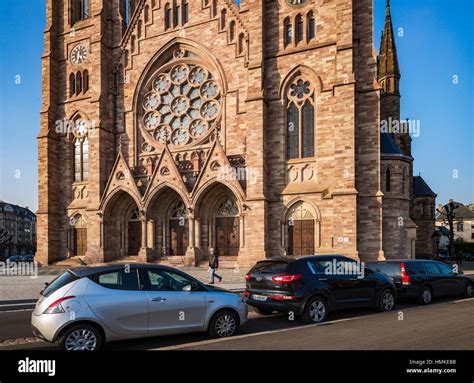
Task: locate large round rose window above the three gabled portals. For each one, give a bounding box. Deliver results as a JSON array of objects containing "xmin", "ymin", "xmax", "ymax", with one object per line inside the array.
[{"xmin": 142, "ymin": 63, "xmax": 222, "ymax": 146}]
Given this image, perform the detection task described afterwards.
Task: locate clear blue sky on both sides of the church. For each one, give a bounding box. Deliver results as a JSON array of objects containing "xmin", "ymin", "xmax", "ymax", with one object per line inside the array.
[{"xmin": 0, "ymin": 0, "xmax": 474, "ymax": 210}]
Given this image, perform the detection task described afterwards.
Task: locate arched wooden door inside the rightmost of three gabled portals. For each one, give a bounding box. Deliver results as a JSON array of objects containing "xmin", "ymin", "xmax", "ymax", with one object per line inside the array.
[{"xmin": 215, "ymin": 198, "xmax": 240, "ymax": 256}]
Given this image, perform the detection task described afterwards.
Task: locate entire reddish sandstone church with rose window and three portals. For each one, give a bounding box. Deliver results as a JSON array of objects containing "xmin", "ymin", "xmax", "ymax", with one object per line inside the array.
[{"xmin": 37, "ymin": 0, "xmax": 436, "ymax": 265}]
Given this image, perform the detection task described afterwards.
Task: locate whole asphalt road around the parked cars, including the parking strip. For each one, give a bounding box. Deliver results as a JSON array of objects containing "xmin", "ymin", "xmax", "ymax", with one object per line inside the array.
[{"xmin": 0, "ymin": 298, "xmax": 474, "ymax": 350}]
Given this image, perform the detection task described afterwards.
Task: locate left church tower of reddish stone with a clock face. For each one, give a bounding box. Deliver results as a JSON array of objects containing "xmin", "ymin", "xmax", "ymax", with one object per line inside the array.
[{"xmin": 38, "ymin": 0, "xmax": 122, "ymax": 263}]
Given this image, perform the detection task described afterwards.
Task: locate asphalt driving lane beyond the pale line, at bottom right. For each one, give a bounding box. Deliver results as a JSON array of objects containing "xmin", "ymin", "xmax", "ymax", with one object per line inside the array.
[{"xmin": 173, "ymin": 299, "xmax": 474, "ymax": 350}]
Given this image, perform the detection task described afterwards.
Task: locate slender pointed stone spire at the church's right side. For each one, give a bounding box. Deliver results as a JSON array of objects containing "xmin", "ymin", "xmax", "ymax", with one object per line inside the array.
[{"xmin": 378, "ymin": 0, "xmax": 400, "ymax": 94}]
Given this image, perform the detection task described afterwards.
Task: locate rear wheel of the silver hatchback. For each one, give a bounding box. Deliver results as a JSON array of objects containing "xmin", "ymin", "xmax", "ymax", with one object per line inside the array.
[{"xmin": 58, "ymin": 324, "xmax": 103, "ymax": 351}]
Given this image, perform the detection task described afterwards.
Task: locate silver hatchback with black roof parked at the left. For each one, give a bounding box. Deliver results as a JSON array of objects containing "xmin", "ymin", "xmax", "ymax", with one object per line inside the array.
[{"xmin": 31, "ymin": 264, "xmax": 248, "ymax": 351}]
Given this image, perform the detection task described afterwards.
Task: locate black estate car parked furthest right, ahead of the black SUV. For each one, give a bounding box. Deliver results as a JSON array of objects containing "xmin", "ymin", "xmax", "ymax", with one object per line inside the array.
[{"xmin": 367, "ymin": 259, "xmax": 473, "ymax": 305}]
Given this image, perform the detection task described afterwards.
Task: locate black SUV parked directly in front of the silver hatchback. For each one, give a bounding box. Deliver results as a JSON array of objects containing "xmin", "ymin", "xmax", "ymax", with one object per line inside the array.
[{"xmin": 245, "ymin": 255, "xmax": 396, "ymax": 323}]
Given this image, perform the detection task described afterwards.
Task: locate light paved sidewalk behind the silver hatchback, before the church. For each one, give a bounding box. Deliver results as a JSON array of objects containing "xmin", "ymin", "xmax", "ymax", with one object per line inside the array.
[{"xmin": 0, "ymin": 266, "xmax": 248, "ymax": 302}]
